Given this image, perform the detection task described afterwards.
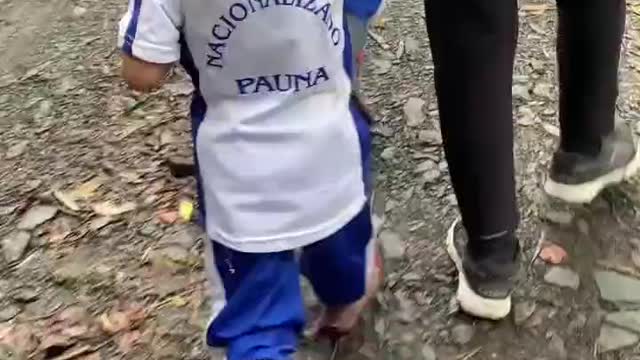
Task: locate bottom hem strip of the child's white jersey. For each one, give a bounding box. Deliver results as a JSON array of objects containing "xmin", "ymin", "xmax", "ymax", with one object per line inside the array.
[{"xmin": 207, "ymin": 196, "xmax": 366, "ymax": 253}]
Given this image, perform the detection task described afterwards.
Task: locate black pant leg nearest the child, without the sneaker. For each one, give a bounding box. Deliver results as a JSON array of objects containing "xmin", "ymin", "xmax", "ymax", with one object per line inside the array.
[{"xmin": 425, "ymin": 0, "xmax": 518, "ymax": 258}]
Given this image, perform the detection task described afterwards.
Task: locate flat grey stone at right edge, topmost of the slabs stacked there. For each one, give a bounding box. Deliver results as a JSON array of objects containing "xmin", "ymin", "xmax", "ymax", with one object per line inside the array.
[{"xmin": 594, "ymin": 271, "xmax": 640, "ymax": 303}]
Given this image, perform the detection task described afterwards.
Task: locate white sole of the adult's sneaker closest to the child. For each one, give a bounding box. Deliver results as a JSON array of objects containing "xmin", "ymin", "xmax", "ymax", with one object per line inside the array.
[{"xmin": 447, "ymin": 220, "xmax": 511, "ymax": 320}]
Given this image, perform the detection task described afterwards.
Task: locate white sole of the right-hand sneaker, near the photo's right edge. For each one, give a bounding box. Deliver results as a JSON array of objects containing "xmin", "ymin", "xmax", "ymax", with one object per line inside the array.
[{"xmin": 544, "ymin": 146, "xmax": 640, "ymax": 204}]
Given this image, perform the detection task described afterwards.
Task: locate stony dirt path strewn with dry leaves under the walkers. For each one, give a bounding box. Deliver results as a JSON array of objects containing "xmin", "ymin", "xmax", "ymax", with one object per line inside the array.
[{"xmin": 0, "ymin": 0, "xmax": 640, "ymax": 360}]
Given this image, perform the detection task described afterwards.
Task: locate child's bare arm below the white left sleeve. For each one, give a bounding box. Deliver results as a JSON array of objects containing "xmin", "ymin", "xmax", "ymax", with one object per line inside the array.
[{"xmin": 122, "ymin": 54, "xmax": 173, "ymax": 91}]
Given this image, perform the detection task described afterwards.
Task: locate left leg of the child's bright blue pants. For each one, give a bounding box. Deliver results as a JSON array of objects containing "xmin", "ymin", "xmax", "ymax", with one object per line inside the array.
[{"xmin": 207, "ymin": 242, "xmax": 305, "ymax": 360}]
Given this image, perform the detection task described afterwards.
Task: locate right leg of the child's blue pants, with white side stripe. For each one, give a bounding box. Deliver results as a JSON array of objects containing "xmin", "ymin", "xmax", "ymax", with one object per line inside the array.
[{"xmin": 300, "ymin": 205, "xmax": 374, "ymax": 306}]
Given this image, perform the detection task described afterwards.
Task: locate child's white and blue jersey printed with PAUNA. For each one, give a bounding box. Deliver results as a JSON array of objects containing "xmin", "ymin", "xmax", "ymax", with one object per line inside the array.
[{"xmin": 119, "ymin": 0, "xmax": 369, "ymax": 253}]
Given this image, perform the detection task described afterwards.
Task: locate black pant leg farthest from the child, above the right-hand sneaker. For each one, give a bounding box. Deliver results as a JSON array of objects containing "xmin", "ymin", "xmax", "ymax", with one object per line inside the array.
[{"xmin": 557, "ymin": 0, "xmax": 625, "ymax": 155}]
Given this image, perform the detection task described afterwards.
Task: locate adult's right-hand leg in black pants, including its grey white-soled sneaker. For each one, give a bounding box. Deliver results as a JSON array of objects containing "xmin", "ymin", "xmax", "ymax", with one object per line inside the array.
[{"xmin": 545, "ymin": 0, "xmax": 640, "ymax": 203}]
